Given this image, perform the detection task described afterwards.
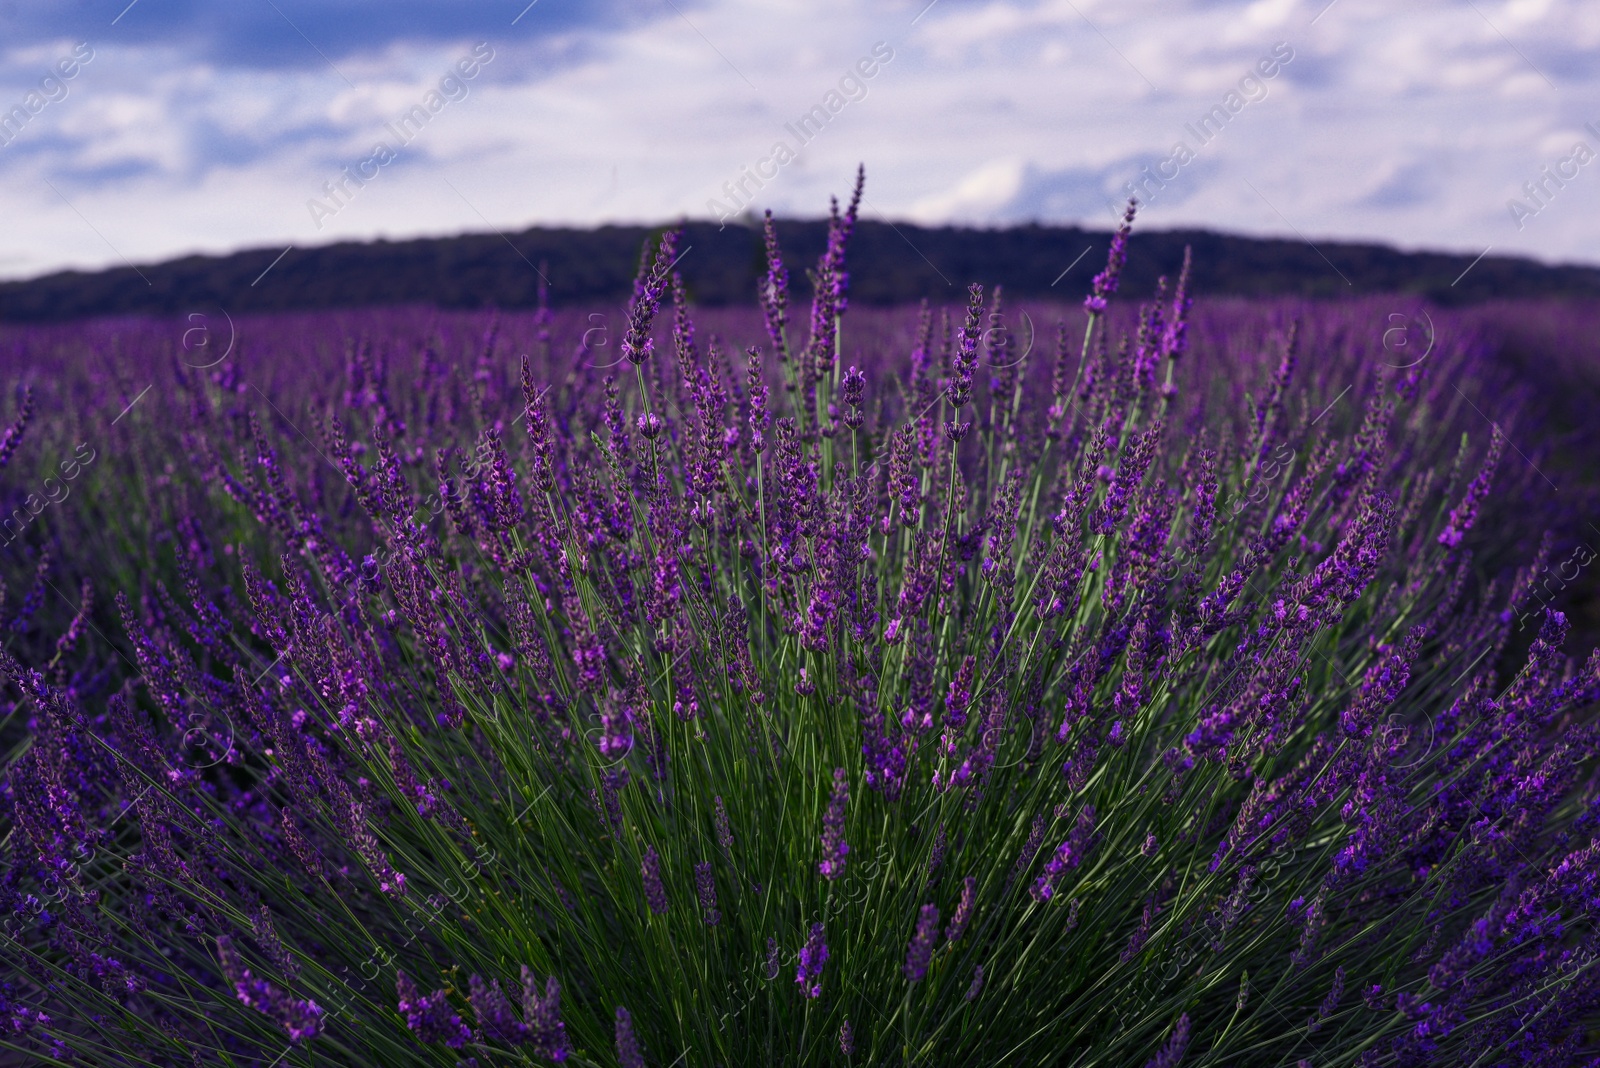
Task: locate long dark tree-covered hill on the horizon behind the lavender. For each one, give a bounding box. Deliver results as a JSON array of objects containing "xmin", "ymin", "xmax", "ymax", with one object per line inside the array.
[{"xmin": 0, "ymin": 219, "xmax": 1600, "ymax": 321}]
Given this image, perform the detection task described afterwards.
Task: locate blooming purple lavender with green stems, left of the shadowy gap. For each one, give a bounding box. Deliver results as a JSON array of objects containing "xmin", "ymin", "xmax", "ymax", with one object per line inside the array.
[{"xmin": 0, "ymin": 185, "xmax": 1600, "ymax": 1068}]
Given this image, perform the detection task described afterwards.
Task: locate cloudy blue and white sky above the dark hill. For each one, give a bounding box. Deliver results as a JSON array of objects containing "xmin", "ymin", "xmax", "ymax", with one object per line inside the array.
[{"xmin": 0, "ymin": 0, "xmax": 1600, "ymax": 278}]
